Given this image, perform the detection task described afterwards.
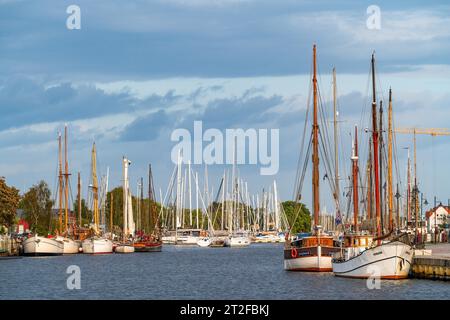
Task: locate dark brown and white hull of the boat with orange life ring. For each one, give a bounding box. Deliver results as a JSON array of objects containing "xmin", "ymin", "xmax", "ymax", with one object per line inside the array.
[{"xmin": 284, "ymin": 246, "xmax": 337, "ymax": 272}]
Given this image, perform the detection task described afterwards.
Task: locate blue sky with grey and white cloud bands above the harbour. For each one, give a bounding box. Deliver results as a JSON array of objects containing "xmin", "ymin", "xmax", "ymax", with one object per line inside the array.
[{"xmin": 0, "ymin": 0, "xmax": 450, "ymax": 215}]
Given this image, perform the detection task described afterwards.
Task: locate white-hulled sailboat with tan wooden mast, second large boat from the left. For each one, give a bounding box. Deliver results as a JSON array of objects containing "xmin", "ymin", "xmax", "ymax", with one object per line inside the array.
[{"xmin": 82, "ymin": 142, "xmax": 113, "ymax": 254}]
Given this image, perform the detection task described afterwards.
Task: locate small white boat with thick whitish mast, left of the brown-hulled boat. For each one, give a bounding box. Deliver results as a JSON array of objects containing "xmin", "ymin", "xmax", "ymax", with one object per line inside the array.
[{"xmin": 115, "ymin": 157, "xmax": 134, "ymax": 253}]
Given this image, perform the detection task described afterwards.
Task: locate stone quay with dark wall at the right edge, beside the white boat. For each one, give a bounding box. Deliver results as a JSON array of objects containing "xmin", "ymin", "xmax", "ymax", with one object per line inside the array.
[{"xmin": 411, "ymin": 243, "xmax": 450, "ymax": 281}]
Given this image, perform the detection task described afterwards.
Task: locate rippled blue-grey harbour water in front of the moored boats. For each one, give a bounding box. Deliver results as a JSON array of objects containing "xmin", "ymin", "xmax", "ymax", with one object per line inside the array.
[{"xmin": 0, "ymin": 244, "xmax": 450, "ymax": 299}]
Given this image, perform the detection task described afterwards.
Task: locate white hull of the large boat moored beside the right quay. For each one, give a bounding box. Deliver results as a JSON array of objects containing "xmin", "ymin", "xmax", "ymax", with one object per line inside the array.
[{"xmin": 333, "ymin": 241, "xmax": 413, "ymax": 279}]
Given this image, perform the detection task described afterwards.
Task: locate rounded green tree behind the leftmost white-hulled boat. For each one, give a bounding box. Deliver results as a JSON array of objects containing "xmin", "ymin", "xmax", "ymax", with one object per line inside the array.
[{"xmin": 19, "ymin": 180, "xmax": 53, "ymax": 234}]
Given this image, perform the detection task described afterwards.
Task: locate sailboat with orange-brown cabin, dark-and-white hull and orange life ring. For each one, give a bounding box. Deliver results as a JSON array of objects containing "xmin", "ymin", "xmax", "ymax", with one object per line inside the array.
[{"xmin": 284, "ymin": 45, "xmax": 339, "ymax": 272}]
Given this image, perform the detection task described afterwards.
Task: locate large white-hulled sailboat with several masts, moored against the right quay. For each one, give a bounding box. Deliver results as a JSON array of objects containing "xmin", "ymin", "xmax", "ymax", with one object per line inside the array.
[{"xmin": 332, "ymin": 54, "xmax": 414, "ymax": 279}]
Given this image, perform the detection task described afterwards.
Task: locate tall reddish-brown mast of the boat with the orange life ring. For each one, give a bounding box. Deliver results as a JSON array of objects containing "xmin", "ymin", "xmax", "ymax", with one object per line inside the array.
[{"xmin": 312, "ymin": 45, "xmax": 320, "ymax": 226}]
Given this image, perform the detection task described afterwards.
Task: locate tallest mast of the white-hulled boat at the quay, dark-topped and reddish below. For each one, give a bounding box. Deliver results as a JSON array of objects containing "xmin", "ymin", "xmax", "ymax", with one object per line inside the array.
[{"xmin": 372, "ymin": 53, "xmax": 381, "ymax": 243}]
